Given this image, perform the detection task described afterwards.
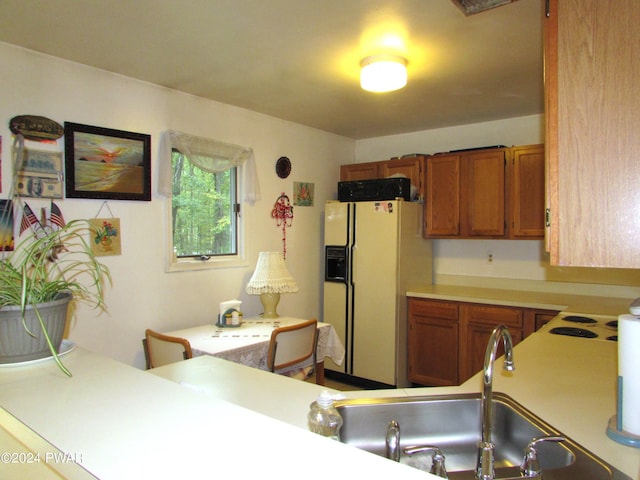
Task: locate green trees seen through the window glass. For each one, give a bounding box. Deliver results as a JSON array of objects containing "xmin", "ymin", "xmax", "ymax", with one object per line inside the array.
[{"xmin": 171, "ymin": 151, "xmax": 237, "ymax": 258}]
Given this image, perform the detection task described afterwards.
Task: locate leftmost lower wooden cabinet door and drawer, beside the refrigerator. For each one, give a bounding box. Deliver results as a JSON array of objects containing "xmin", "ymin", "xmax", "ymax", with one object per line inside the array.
[{"xmin": 408, "ymin": 298, "xmax": 459, "ymax": 386}]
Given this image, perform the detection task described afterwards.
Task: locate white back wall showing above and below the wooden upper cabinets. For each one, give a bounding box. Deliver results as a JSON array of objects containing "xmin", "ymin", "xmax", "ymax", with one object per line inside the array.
[{"xmin": 356, "ymin": 115, "xmax": 640, "ymax": 295}]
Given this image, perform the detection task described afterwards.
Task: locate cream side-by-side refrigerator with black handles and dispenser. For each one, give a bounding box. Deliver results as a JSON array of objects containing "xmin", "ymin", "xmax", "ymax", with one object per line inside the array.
[{"xmin": 323, "ymin": 200, "xmax": 433, "ymax": 387}]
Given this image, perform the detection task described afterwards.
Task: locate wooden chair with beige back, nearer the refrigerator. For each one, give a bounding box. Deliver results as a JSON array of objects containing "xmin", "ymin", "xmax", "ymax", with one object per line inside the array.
[{"xmin": 267, "ymin": 319, "xmax": 318, "ymax": 383}]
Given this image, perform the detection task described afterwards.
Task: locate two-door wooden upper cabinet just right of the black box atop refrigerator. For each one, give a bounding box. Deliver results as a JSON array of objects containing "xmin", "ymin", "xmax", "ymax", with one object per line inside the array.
[{"xmin": 425, "ymin": 149, "xmax": 505, "ymax": 238}]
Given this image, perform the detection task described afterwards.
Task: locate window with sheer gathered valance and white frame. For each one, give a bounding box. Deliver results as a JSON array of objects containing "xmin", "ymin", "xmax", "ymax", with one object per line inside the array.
[{"xmin": 158, "ymin": 131, "xmax": 260, "ymax": 271}]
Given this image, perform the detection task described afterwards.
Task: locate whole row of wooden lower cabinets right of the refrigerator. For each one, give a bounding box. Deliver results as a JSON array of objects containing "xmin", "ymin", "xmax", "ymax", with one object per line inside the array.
[{"xmin": 408, "ymin": 298, "xmax": 558, "ymax": 386}]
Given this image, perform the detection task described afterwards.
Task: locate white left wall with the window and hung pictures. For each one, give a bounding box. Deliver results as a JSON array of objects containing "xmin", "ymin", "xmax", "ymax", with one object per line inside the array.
[{"xmin": 0, "ymin": 43, "xmax": 355, "ymax": 367}]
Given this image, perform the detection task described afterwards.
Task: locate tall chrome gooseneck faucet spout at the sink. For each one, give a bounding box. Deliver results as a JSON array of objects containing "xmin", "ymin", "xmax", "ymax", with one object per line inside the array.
[{"xmin": 476, "ymin": 325, "xmax": 515, "ymax": 480}]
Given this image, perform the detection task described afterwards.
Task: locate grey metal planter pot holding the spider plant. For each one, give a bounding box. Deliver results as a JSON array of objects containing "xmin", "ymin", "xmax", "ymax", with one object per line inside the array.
[{"xmin": 0, "ymin": 293, "xmax": 73, "ymax": 364}]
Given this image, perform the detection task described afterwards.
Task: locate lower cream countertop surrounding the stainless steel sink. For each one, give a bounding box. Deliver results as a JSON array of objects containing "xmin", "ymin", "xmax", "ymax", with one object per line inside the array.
[{"xmin": 151, "ymin": 320, "xmax": 640, "ymax": 480}]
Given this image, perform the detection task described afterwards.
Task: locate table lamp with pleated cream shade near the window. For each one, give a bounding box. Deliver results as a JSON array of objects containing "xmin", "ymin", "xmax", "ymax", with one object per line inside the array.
[{"xmin": 246, "ymin": 252, "xmax": 298, "ymax": 318}]
